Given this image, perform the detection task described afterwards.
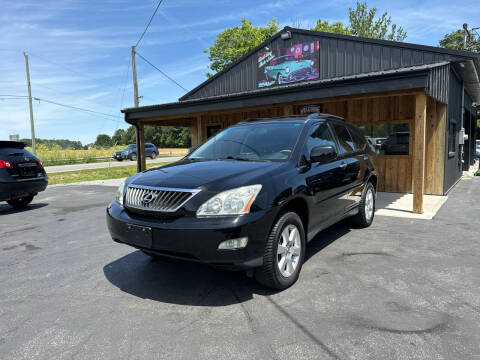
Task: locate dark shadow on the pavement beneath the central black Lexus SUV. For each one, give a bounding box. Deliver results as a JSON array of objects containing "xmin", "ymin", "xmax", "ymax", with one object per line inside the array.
[{"xmin": 103, "ymin": 222, "xmax": 350, "ymax": 306}]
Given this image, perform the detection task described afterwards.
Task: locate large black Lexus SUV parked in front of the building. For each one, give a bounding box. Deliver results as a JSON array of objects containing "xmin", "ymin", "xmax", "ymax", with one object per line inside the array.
[{"xmin": 107, "ymin": 114, "xmax": 377, "ymax": 289}]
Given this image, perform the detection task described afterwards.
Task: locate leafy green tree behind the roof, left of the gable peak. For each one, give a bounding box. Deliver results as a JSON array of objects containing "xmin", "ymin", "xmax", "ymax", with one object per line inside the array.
[{"xmin": 204, "ymin": 18, "xmax": 279, "ymax": 77}]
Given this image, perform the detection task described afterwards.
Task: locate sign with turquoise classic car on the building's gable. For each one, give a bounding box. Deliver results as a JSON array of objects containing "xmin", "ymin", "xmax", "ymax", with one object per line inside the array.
[{"xmin": 258, "ymin": 41, "xmax": 319, "ymax": 88}]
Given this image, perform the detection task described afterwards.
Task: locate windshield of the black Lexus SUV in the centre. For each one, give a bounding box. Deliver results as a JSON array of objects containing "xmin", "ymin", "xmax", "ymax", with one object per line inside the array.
[{"xmin": 188, "ymin": 122, "xmax": 302, "ymax": 161}]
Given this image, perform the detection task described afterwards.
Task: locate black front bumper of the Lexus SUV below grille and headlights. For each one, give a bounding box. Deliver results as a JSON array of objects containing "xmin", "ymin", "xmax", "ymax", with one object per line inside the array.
[{"xmin": 107, "ymin": 201, "xmax": 275, "ymax": 270}]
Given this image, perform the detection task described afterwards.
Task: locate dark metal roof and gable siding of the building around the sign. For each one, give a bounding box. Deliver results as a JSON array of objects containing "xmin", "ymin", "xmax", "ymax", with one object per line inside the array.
[{"xmin": 122, "ymin": 27, "xmax": 480, "ymax": 123}]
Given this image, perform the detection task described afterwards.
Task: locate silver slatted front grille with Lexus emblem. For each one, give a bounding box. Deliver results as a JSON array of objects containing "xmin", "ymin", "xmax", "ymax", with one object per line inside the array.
[{"xmin": 125, "ymin": 185, "xmax": 199, "ymax": 213}]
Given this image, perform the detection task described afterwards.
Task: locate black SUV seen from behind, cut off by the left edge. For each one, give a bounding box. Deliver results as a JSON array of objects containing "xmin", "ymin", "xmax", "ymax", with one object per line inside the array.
[{"xmin": 0, "ymin": 141, "xmax": 48, "ymax": 208}]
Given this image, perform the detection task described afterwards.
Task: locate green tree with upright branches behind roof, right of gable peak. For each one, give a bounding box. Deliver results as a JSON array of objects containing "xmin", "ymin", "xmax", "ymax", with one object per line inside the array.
[{"xmin": 348, "ymin": 0, "xmax": 407, "ymax": 41}]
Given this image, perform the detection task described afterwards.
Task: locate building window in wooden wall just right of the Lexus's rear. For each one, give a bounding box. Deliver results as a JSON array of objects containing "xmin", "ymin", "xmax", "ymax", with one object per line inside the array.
[{"xmin": 359, "ymin": 123, "xmax": 410, "ymax": 155}]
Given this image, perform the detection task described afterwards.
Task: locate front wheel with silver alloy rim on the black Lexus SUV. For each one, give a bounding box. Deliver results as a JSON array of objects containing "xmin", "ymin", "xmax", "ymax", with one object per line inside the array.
[{"xmin": 254, "ymin": 212, "xmax": 306, "ymax": 290}]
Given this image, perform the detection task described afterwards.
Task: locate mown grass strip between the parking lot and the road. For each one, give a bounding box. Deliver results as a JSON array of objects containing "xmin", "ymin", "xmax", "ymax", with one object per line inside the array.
[{"xmin": 48, "ymin": 162, "xmax": 169, "ymax": 185}]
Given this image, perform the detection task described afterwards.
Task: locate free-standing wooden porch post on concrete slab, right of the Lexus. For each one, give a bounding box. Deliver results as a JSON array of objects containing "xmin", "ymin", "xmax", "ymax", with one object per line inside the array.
[{"xmin": 412, "ymin": 92, "xmax": 427, "ymax": 214}]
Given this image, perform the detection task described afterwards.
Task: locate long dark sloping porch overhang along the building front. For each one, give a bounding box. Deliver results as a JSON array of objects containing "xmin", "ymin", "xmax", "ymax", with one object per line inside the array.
[{"xmin": 122, "ymin": 63, "xmax": 442, "ymax": 125}]
